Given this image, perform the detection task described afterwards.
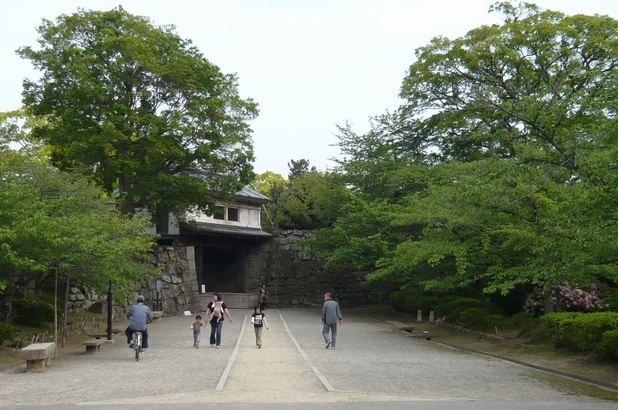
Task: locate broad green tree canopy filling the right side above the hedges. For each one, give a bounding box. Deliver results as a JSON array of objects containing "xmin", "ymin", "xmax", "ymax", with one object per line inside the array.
[{"xmin": 320, "ymin": 2, "xmax": 618, "ymax": 306}]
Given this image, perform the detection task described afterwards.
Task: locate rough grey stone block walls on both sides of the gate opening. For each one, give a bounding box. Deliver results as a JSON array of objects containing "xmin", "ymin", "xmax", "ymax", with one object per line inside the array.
[{"xmin": 61, "ymin": 230, "xmax": 396, "ymax": 317}]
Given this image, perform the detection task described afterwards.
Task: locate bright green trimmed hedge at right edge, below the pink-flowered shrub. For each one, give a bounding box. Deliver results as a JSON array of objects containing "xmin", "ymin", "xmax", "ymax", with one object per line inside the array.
[{"xmin": 541, "ymin": 312, "xmax": 618, "ymax": 357}]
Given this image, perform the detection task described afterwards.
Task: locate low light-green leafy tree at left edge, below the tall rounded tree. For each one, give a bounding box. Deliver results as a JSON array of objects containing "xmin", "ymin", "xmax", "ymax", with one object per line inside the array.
[{"xmin": 0, "ymin": 150, "xmax": 156, "ymax": 321}]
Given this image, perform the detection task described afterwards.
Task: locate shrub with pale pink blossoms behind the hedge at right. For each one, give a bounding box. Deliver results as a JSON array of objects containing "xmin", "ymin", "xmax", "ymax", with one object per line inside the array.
[{"xmin": 526, "ymin": 282, "xmax": 601, "ymax": 317}]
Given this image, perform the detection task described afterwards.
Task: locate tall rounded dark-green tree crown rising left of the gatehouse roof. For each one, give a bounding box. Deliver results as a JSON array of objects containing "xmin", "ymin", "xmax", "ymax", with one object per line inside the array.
[{"xmin": 18, "ymin": 6, "xmax": 257, "ymax": 218}]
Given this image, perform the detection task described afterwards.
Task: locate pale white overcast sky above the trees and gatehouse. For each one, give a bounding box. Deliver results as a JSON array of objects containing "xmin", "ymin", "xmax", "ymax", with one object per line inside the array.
[{"xmin": 0, "ymin": 0, "xmax": 618, "ymax": 177}]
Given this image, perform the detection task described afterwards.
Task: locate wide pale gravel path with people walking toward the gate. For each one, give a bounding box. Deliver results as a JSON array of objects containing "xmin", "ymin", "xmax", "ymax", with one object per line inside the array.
[{"xmin": 0, "ymin": 309, "xmax": 608, "ymax": 406}]
